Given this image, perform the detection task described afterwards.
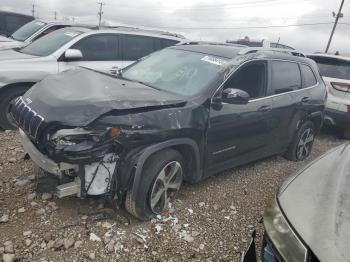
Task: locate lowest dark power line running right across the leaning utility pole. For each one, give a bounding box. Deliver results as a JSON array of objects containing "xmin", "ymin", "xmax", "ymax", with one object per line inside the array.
[{"xmin": 153, "ymin": 22, "xmax": 350, "ymax": 30}]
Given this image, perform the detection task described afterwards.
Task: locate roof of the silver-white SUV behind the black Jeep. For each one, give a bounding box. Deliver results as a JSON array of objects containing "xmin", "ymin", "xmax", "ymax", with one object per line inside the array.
[{"xmin": 66, "ymin": 25, "xmax": 186, "ymax": 41}]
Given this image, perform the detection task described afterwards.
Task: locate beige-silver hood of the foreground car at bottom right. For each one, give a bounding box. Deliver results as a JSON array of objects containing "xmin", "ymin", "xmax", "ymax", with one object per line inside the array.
[{"xmin": 278, "ymin": 144, "xmax": 350, "ymax": 262}]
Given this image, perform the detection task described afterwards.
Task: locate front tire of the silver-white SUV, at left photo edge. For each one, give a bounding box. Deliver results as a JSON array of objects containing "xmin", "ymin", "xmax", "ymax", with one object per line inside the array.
[{"xmin": 0, "ymin": 86, "xmax": 29, "ymax": 130}]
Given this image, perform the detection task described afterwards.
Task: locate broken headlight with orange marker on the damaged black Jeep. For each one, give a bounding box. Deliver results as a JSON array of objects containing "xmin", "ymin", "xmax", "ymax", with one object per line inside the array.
[{"xmin": 50, "ymin": 127, "xmax": 120, "ymax": 151}]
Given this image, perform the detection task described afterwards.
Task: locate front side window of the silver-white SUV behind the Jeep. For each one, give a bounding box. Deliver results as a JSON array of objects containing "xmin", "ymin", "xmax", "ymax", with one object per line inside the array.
[{"xmin": 72, "ymin": 34, "xmax": 118, "ymax": 61}]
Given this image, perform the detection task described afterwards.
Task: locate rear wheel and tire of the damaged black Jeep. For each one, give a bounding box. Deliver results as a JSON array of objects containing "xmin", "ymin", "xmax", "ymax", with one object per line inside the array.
[{"xmin": 284, "ymin": 121, "xmax": 315, "ymax": 161}]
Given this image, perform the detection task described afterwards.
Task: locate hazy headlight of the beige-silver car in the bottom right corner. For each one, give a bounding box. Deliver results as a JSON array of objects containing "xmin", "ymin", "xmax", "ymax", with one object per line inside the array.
[{"xmin": 263, "ymin": 199, "xmax": 307, "ymax": 262}]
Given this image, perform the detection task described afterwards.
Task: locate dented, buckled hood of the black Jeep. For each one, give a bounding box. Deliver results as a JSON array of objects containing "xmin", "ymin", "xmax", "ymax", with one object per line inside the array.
[{"xmin": 24, "ymin": 68, "xmax": 185, "ymax": 126}]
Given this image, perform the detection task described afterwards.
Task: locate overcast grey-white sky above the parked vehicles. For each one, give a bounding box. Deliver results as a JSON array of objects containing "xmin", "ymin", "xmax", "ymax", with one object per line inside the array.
[{"xmin": 0, "ymin": 0, "xmax": 350, "ymax": 54}]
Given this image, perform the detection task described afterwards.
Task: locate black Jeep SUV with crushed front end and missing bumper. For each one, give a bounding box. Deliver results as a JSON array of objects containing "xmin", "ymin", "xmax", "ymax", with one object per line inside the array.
[{"xmin": 11, "ymin": 44, "xmax": 326, "ymax": 219}]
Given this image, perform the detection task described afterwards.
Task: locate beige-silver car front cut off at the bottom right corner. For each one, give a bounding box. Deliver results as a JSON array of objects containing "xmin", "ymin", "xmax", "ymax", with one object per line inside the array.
[{"xmin": 243, "ymin": 144, "xmax": 350, "ymax": 262}]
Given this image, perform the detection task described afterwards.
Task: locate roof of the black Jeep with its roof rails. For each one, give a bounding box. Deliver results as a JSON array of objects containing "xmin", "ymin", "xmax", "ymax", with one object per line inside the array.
[{"xmin": 169, "ymin": 42, "xmax": 314, "ymax": 63}]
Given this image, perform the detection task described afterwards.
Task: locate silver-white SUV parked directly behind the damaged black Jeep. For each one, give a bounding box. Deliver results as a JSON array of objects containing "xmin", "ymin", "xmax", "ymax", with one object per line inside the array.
[{"xmin": 0, "ymin": 27, "xmax": 185, "ymax": 129}]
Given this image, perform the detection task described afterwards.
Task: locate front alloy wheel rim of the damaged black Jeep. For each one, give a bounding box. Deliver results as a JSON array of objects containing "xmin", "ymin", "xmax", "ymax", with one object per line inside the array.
[{"xmin": 150, "ymin": 161, "xmax": 183, "ymax": 214}]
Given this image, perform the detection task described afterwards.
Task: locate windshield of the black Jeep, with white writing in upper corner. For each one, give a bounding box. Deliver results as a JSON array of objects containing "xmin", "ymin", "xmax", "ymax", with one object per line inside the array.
[{"xmin": 122, "ymin": 49, "xmax": 226, "ymax": 96}]
